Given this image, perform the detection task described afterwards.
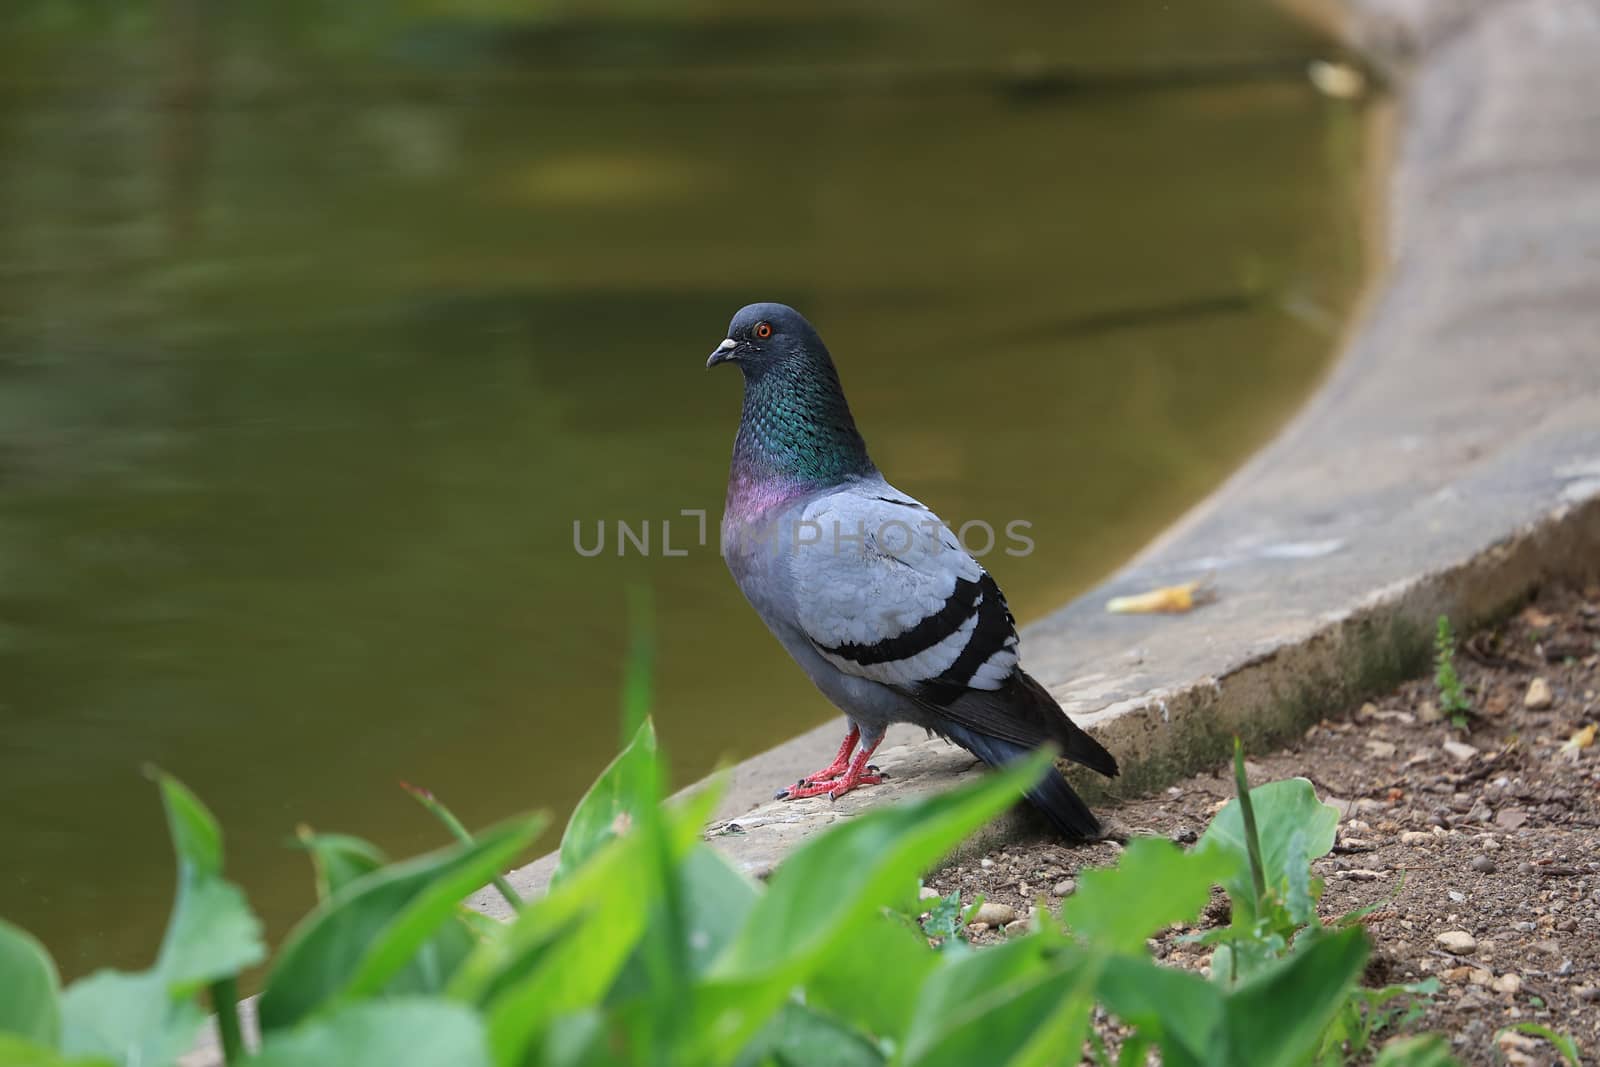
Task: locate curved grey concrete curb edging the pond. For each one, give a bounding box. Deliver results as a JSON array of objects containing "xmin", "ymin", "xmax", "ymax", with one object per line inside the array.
[{"xmin": 474, "ymin": 0, "xmax": 1600, "ymax": 913}]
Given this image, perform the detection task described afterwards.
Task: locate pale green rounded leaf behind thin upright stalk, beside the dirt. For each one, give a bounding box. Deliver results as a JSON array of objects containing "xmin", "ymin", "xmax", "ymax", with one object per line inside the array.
[{"xmin": 1195, "ymin": 777, "xmax": 1339, "ymax": 912}]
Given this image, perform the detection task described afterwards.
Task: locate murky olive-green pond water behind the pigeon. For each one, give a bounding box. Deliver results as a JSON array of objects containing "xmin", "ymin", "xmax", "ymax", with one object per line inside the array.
[{"xmin": 0, "ymin": 0, "xmax": 1362, "ymax": 974}]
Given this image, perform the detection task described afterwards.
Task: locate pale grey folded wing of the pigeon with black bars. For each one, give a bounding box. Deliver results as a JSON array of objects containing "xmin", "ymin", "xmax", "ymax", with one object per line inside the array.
[{"xmin": 789, "ymin": 482, "xmax": 1018, "ymax": 705}]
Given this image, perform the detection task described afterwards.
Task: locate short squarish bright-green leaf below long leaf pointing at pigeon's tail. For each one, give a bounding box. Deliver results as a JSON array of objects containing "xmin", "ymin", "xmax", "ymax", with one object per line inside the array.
[{"xmin": 805, "ymin": 915, "xmax": 939, "ymax": 1038}]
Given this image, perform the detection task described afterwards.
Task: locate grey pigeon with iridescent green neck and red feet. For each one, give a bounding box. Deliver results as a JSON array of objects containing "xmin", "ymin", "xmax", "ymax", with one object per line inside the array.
[{"xmin": 706, "ymin": 304, "xmax": 1117, "ymax": 840}]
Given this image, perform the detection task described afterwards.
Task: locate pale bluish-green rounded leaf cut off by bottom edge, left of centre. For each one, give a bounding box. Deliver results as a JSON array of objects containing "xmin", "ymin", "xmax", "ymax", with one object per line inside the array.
[{"xmin": 248, "ymin": 997, "xmax": 490, "ymax": 1067}]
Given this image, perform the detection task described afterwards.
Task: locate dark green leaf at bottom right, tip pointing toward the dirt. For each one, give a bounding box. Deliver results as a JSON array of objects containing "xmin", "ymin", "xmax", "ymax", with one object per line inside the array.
[{"xmin": 1211, "ymin": 928, "xmax": 1366, "ymax": 1067}]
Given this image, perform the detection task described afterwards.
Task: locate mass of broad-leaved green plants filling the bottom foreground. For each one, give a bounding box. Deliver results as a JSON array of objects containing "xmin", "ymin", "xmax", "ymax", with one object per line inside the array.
[{"xmin": 0, "ymin": 668, "xmax": 1472, "ymax": 1067}]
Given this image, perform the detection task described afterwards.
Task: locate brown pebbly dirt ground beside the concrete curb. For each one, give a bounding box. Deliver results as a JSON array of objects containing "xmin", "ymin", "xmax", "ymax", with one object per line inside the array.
[{"xmin": 928, "ymin": 587, "xmax": 1600, "ymax": 1064}]
